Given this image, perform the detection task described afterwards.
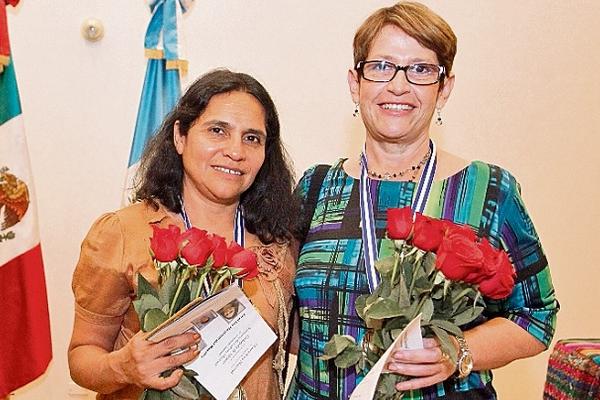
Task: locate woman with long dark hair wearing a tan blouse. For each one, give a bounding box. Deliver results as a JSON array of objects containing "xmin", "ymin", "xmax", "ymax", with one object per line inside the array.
[{"xmin": 69, "ymin": 70, "xmax": 297, "ymax": 400}]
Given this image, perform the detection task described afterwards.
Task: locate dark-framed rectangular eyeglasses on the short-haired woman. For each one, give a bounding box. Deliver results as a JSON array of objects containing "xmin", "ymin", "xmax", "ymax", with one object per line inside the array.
[{"xmin": 355, "ymin": 60, "xmax": 445, "ymax": 86}]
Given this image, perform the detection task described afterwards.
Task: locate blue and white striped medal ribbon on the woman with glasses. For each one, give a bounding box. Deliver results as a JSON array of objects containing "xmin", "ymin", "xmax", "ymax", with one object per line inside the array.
[{"xmin": 360, "ymin": 139, "xmax": 437, "ymax": 293}]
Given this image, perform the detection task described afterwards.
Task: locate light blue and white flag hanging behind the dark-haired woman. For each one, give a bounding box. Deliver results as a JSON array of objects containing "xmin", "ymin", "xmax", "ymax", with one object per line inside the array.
[{"xmin": 123, "ymin": 0, "xmax": 193, "ymax": 205}]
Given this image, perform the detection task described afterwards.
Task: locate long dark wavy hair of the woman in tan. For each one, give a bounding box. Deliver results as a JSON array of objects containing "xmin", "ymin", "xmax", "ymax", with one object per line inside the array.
[{"xmin": 135, "ymin": 69, "xmax": 299, "ymax": 244}]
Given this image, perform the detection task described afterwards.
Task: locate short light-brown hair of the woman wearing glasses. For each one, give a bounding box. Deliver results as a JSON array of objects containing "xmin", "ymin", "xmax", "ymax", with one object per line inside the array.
[{"xmin": 354, "ymin": 1, "xmax": 456, "ymax": 75}]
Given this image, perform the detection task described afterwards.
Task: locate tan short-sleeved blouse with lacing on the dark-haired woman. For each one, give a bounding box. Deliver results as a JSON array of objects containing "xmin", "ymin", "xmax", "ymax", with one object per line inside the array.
[{"xmin": 72, "ymin": 203, "xmax": 295, "ymax": 400}]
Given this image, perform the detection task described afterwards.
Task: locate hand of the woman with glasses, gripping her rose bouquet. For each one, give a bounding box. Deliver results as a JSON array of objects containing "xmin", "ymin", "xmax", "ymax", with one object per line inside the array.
[{"xmin": 387, "ymin": 338, "xmax": 456, "ymax": 391}]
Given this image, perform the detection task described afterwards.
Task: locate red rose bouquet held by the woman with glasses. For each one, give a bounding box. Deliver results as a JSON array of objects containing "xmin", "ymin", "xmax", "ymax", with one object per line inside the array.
[{"xmin": 321, "ymin": 207, "xmax": 515, "ymax": 398}]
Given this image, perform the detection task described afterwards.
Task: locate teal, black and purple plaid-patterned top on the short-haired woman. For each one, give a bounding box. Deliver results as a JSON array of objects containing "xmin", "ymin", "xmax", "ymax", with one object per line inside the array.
[{"xmin": 287, "ymin": 159, "xmax": 559, "ymax": 400}]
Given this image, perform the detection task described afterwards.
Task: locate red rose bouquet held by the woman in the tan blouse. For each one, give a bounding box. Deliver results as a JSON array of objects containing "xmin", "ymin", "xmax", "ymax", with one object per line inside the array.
[{"xmin": 133, "ymin": 225, "xmax": 258, "ymax": 400}]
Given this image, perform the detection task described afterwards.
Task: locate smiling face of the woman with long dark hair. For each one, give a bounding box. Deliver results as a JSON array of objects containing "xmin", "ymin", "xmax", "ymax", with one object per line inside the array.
[{"xmin": 174, "ymin": 91, "xmax": 266, "ymax": 205}]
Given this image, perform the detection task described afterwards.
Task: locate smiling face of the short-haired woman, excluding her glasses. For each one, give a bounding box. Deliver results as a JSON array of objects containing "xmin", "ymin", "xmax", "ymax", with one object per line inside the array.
[{"xmin": 348, "ymin": 25, "xmax": 454, "ymax": 143}]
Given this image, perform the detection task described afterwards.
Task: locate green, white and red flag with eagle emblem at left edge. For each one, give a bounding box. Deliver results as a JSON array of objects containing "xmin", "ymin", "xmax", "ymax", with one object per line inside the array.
[{"xmin": 0, "ymin": 0, "xmax": 52, "ymax": 399}]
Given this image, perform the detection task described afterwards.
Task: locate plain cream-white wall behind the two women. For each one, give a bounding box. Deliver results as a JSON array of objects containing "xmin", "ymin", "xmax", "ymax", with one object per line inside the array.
[{"xmin": 9, "ymin": 0, "xmax": 600, "ymax": 400}]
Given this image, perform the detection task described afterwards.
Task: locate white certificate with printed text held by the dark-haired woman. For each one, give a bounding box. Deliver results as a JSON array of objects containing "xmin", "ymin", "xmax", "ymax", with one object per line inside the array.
[{"xmin": 148, "ymin": 285, "xmax": 277, "ymax": 400}]
